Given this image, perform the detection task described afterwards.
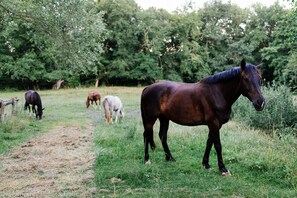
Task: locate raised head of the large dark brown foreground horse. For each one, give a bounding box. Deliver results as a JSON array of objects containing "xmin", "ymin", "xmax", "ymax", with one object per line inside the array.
[{"xmin": 240, "ymin": 60, "xmax": 265, "ymax": 111}]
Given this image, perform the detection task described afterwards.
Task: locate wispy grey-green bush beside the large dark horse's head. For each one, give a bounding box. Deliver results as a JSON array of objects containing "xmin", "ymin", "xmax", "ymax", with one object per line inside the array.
[{"xmin": 233, "ymin": 85, "xmax": 297, "ymax": 136}]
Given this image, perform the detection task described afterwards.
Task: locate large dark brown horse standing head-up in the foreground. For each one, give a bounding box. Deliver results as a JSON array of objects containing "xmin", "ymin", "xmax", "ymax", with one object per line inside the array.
[{"xmin": 141, "ymin": 60, "xmax": 265, "ymax": 175}]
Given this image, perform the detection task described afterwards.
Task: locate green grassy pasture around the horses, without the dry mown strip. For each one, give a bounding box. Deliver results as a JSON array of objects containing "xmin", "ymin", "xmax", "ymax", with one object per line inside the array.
[{"xmin": 0, "ymin": 87, "xmax": 297, "ymax": 197}]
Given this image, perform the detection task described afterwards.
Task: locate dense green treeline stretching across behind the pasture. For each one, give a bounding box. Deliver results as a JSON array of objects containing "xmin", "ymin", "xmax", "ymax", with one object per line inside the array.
[{"xmin": 0, "ymin": 0, "xmax": 297, "ymax": 90}]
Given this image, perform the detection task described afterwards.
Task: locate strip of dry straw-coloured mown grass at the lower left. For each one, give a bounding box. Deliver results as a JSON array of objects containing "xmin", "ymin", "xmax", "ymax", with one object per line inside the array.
[{"xmin": 0, "ymin": 126, "xmax": 95, "ymax": 197}]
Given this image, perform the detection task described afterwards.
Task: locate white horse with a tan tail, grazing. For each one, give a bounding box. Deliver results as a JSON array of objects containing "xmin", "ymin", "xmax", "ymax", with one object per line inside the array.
[{"xmin": 102, "ymin": 96, "xmax": 124, "ymax": 124}]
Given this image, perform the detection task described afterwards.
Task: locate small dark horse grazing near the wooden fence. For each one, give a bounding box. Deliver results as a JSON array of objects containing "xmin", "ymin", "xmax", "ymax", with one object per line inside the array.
[{"xmin": 24, "ymin": 90, "xmax": 44, "ymax": 120}]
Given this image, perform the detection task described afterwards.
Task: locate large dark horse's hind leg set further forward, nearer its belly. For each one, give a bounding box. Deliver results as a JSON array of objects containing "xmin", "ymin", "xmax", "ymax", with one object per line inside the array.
[{"xmin": 159, "ymin": 117, "xmax": 175, "ymax": 162}]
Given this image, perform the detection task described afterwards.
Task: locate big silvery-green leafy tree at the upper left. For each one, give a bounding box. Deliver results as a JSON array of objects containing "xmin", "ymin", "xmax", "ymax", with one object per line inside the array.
[{"xmin": 0, "ymin": 0, "xmax": 104, "ymax": 87}]
